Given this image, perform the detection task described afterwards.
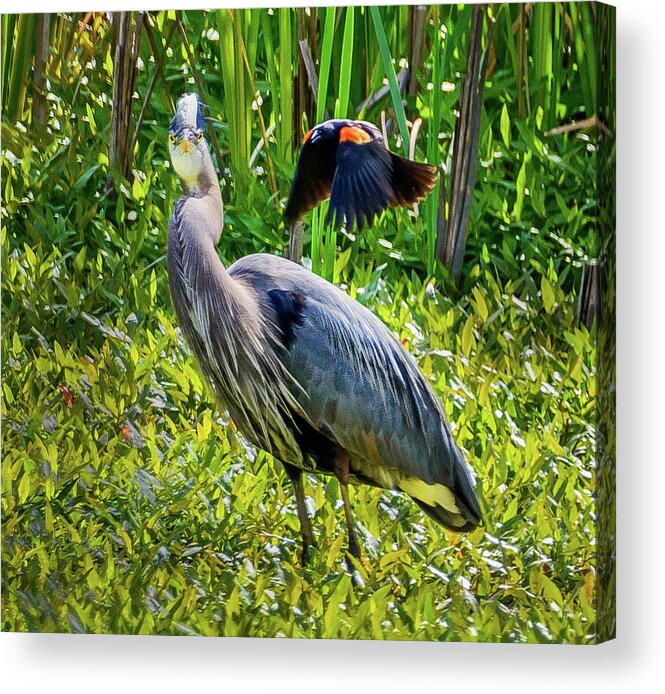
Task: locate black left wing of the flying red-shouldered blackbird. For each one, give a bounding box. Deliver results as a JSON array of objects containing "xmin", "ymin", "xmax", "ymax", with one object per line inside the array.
[{"xmin": 284, "ymin": 133, "xmax": 335, "ymax": 225}]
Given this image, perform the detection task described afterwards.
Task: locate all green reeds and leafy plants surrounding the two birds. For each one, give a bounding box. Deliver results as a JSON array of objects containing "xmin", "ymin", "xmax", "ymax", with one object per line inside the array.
[{"xmin": 1, "ymin": 3, "xmax": 613, "ymax": 643}]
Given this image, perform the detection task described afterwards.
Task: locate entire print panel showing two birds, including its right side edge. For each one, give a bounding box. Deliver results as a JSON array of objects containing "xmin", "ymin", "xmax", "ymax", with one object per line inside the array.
[{"xmin": 2, "ymin": 2, "xmax": 615, "ymax": 644}]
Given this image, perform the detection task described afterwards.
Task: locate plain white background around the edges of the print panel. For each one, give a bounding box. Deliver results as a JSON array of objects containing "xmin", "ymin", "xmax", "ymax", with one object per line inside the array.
[{"xmin": 0, "ymin": 0, "xmax": 665, "ymax": 694}]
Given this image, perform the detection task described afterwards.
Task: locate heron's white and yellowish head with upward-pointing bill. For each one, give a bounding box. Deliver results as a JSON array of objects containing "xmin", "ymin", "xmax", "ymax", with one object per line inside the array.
[{"xmin": 169, "ymin": 94, "xmax": 210, "ymax": 188}]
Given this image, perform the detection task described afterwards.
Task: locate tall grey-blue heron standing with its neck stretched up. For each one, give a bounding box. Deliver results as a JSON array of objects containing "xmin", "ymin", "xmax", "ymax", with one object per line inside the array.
[{"xmin": 168, "ymin": 94, "xmax": 480, "ymax": 561}]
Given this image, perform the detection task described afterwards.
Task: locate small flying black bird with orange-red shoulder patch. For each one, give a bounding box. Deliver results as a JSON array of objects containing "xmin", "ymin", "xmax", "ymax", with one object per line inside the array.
[{"xmin": 284, "ymin": 119, "xmax": 436, "ymax": 229}]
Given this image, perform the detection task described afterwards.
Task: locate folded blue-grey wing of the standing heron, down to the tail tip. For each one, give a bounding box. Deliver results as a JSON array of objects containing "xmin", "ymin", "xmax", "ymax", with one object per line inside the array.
[{"xmin": 278, "ymin": 280, "xmax": 480, "ymax": 530}]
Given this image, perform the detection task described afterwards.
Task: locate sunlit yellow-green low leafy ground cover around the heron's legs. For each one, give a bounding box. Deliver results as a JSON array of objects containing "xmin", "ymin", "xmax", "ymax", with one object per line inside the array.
[{"xmin": 2, "ymin": 215, "xmax": 594, "ymax": 642}]
